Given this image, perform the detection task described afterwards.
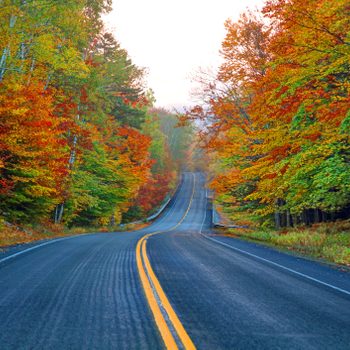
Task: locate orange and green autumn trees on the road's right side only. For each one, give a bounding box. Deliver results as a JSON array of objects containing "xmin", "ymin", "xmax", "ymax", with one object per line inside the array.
[{"xmin": 181, "ymin": 0, "xmax": 350, "ymax": 229}]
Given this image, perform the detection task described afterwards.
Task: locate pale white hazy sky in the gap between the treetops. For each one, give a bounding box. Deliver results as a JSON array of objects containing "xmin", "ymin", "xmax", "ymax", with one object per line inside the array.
[{"xmin": 107, "ymin": 0, "xmax": 263, "ymax": 109}]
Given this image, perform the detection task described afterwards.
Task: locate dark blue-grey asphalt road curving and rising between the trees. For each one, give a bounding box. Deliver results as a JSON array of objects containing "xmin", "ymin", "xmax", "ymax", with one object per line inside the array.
[{"xmin": 0, "ymin": 173, "xmax": 350, "ymax": 350}]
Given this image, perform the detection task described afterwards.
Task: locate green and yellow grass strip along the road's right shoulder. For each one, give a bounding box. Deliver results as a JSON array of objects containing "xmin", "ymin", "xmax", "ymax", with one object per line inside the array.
[{"xmin": 229, "ymin": 220, "xmax": 350, "ymax": 266}]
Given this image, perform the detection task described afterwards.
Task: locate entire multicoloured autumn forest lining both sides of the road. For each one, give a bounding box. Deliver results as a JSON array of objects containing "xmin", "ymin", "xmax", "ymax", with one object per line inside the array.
[{"xmin": 0, "ymin": 0, "xmax": 350, "ymax": 249}]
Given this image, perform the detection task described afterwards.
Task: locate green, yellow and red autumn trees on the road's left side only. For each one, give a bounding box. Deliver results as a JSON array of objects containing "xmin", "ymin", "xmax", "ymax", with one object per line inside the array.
[{"xmin": 0, "ymin": 0, "xmax": 192, "ymax": 235}]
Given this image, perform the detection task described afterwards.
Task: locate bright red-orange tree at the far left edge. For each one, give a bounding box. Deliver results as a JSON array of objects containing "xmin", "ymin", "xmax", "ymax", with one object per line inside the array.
[{"xmin": 0, "ymin": 82, "xmax": 69, "ymax": 220}]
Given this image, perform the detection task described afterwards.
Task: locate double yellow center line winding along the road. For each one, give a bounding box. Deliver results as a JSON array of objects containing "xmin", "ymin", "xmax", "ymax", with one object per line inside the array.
[{"xmin": 136, "ymin": 175, "xmax": 196, "ymax": 350}]
